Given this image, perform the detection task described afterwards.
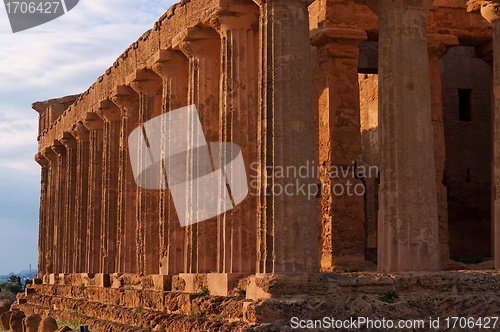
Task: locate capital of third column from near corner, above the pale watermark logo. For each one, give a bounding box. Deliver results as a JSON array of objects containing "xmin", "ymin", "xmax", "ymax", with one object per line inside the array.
[{"xmin": 172, "ymin": 27, "xmax": 220, "ymax": 58}]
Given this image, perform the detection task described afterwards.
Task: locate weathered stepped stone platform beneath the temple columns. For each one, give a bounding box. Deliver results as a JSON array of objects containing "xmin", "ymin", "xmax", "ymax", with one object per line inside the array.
[{"xmin": 9, "ymin": 271, "xmax": 500, "ymax": 332}]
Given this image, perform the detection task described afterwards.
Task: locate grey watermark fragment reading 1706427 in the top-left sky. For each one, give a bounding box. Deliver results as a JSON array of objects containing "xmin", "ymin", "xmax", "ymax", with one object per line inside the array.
[{"xmin": 4, "ymin": 0, "xmax": 79, "ymax": 33}]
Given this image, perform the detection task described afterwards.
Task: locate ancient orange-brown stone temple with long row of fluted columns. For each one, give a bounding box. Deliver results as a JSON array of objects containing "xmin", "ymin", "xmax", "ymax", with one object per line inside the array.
[{"xmin": 9, "ymin": 0, "xmax": 500, "ymax": 331}]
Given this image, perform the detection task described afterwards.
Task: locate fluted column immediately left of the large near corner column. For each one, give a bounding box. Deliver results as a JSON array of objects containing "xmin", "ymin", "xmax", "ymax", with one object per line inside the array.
[{"xmin": 211, "ymin": 4, "xmax": 259, "ymax": 276}]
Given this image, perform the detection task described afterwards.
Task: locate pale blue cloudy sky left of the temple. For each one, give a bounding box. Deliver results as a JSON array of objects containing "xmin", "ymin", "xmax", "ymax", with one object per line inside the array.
[{"xmin": 0, "ymin": 0, "xmax": 176, "ymax": 275}]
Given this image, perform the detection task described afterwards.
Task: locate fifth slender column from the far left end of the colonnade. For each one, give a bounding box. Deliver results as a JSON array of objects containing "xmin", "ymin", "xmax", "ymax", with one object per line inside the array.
[{"xmin": 71, "ymin": 122, "xmax": 90, "ymax": 273}]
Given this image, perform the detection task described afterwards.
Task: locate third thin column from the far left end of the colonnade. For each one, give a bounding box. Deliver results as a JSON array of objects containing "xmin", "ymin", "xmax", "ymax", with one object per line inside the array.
[{"xmin": 51, "ymin": 140, "xmax": 67, "ymax": 273}]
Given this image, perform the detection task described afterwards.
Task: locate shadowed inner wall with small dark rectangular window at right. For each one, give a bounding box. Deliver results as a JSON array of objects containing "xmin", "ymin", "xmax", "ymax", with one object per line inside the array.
[{"xmin": 442, "ymin": 47, "xmax": 492, "ymax": 258}]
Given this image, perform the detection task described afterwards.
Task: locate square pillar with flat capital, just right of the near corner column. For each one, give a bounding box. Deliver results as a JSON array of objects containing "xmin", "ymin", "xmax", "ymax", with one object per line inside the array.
[{"xmin": 312, "ymin": 28, "xmax": 368, "ymax": 269}]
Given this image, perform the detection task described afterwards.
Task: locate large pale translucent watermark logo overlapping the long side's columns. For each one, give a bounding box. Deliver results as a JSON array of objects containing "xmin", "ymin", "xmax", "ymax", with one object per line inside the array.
[{"xmin": 128, "ymin": 105, "xmax": 248, "ymax": 227}]
